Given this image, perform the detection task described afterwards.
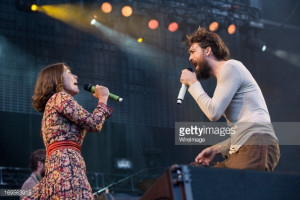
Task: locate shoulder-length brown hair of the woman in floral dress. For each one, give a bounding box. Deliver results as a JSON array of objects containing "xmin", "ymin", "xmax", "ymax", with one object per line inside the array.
[{"xmin": 32, "ymin": 63, "xmax": 70, "ymax": 112}]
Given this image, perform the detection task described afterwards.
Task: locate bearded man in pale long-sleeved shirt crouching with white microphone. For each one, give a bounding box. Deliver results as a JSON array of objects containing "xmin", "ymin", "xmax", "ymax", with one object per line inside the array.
[{"xmin": 180, "ymin": 27, "xmax": 280, "ymax": 171}]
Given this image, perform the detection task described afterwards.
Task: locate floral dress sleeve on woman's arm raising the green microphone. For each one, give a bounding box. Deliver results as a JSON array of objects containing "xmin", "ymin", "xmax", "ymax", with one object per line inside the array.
[{"xmin": 55, "ymin": 92, "xmax": 113, "ymax": 132}]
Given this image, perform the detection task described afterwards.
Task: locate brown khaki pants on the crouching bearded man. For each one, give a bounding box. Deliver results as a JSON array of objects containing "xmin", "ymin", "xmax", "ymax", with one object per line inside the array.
[{"xmin": 213, "ymin": 134, "xmax": 280, "ymax": 171}]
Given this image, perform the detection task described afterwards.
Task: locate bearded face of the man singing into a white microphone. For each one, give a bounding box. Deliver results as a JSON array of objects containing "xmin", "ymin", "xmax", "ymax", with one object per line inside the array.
[{"xmin": 189, "ymin": 43, "xmax": 212, "ymax": 80}]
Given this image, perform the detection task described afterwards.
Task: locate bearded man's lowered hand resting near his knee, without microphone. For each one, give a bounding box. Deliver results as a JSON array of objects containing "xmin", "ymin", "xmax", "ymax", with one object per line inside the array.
[{"xmin": 195, "ymin": 146, "xmax": 220, "ymax": 166}]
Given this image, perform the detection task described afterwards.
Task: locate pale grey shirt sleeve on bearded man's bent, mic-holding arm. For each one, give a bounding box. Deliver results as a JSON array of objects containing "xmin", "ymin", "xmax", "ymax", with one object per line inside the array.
[{"xmin": 189, "ymin": 64, "xmax": 243, "ymax": 121}]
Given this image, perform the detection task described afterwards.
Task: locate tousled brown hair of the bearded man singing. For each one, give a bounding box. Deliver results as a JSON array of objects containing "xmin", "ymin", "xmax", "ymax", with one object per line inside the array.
[{"xmin": 185, "ymin": 27, "xmax": 230, "ymax": 60}]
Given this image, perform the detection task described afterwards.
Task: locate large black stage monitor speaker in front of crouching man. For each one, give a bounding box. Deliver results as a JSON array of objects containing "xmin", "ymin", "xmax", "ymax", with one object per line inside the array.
[{"xmin": 141, "ymin": 165, "xmax": 300, "ymax": 200}]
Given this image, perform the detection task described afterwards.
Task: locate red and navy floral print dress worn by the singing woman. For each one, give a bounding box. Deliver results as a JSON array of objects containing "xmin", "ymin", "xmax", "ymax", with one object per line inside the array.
[{"xmin": 25, "ymin": 92, "xmax": 113, "ymax": 199}]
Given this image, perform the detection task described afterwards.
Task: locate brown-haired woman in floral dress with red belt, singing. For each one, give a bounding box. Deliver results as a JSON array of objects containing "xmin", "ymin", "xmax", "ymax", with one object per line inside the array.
[{"xmin": 25, "ymin": 63, "xmax": 112, "ymax": 199}]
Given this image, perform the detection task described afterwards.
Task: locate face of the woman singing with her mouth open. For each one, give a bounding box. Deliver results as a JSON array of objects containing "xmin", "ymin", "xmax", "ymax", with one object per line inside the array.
[{"xmin": 62, "ymin": 66, "xmax": 79, "ymax": 96}]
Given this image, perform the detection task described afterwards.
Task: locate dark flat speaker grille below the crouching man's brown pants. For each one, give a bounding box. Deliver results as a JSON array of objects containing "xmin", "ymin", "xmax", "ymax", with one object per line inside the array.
[{"xmin": 190, "ymin": 167, "xmax": 300, "ymax": 200}]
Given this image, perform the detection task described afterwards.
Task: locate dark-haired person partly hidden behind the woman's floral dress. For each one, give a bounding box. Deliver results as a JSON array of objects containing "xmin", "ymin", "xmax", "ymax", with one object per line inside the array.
[{"xmin": 20, "ymin": 149, "xmax": 46, "ymax": 199}]
